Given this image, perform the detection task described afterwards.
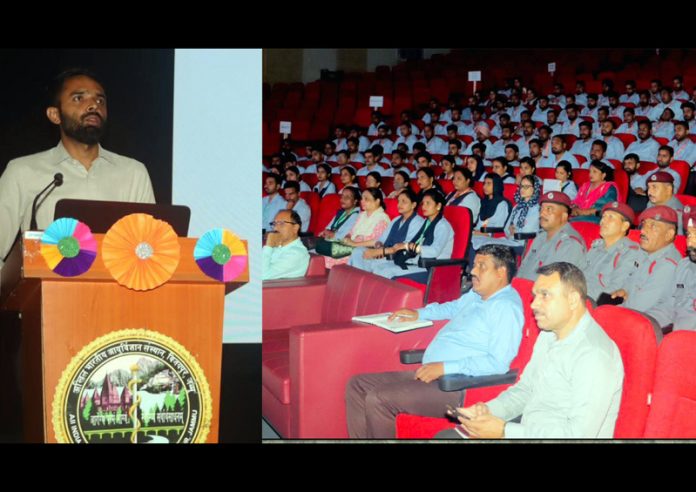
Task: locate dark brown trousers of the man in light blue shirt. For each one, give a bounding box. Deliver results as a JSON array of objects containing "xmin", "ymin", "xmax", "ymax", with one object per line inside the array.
[{"xmin": 346, "ymin": 371, "xmax": 464, "ymax": 439}]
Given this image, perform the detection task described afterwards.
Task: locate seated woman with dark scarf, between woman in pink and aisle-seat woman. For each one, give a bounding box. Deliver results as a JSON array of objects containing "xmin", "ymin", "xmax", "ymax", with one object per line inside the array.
[{"xmin": 348, "ymin": 188, "xmax": 424, "ymax": 272}]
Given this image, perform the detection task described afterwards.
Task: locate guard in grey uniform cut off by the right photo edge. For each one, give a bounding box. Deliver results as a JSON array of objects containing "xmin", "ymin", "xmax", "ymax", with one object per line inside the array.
[{"xmin": 655, "ymin": 205, "xmax": 696, "ymax": 331}]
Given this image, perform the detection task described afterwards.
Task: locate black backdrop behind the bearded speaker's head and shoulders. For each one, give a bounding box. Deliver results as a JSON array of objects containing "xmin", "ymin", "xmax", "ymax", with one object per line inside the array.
[{"xmin": 0, "ymin": 49, "xmax": 174, "ymax": 203}]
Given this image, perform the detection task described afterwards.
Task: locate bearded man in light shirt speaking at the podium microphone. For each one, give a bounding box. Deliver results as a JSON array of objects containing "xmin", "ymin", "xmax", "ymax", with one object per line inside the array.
[{"xmin": 0, "ymin": 69, "xmax": 155, "ymax": 269}]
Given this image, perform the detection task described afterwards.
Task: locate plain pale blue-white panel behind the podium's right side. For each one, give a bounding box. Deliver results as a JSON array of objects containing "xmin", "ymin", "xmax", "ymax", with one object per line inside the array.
[{"xmin": 172, "ymin": 49, "xmax": 261, "ymax": 343}]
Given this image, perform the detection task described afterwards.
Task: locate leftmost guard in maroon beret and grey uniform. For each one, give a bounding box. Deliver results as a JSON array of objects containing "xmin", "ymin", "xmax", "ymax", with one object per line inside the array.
[{"xmin": 517, "ymin": 191, "xmax": 586, "ymax": 280}]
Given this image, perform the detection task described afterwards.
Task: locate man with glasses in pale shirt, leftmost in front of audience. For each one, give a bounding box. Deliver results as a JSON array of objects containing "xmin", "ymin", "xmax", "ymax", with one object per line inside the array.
[{"xmin": 262, "ymin": 210, "xmax": 309, "ymax": 280}]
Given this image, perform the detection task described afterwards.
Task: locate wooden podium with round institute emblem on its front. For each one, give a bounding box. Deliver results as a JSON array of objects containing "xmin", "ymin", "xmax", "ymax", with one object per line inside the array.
[{"xmin": 0, "ymin": 234, "xmax": 249, "ymax": 443}]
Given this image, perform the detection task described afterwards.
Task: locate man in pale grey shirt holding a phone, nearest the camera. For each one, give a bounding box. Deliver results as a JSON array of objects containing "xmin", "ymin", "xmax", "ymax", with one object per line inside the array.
[{"xmin": 437, "ymin": 262, "xmax": 624, "ymax": 439}]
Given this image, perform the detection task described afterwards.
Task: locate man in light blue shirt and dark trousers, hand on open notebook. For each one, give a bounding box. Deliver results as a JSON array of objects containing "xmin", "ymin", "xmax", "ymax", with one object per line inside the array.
[{"xmin": 346, "ymin": 244, "xmax": 524, "ymax": 439}]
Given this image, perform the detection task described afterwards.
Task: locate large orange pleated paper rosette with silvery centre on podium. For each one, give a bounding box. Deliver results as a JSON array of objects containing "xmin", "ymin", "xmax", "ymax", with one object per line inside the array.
[{"xmin": 101, "ymin": 214, "xmax": 180, "ymax": 290}]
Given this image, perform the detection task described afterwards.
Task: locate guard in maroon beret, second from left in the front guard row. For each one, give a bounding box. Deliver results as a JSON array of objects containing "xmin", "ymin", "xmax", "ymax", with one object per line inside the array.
[{"xmin": 583, "ymin": 202, "xmax": 647, "ymax": 300}]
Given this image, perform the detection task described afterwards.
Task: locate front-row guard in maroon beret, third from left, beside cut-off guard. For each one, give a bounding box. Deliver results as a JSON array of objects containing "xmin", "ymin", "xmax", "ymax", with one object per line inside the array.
[{"xmin": 612, "ymin": 205, "xmax": 681, "ymax": 327}]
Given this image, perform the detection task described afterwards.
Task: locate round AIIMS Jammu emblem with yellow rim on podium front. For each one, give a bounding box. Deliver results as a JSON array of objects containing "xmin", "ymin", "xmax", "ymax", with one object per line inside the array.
[{"xmin": 53, "ymin": 330, "xmax": 212, "ymax": 444}]
